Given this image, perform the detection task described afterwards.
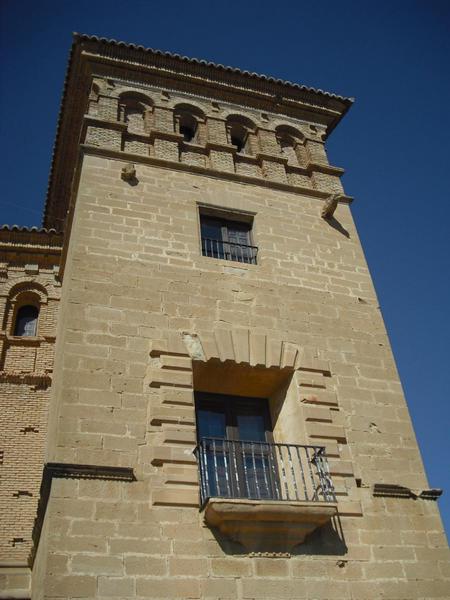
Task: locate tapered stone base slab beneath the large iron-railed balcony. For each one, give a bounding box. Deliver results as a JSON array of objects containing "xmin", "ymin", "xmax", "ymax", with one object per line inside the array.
[{"xmin": 204, "ymin": 498, "xmax": 337, "ymax": 552}]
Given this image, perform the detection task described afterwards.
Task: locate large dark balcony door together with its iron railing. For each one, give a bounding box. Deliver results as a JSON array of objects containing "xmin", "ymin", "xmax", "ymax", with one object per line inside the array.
[{"xmin": 195, "ymin": 392, "xmax": 336, "ymax": 506}]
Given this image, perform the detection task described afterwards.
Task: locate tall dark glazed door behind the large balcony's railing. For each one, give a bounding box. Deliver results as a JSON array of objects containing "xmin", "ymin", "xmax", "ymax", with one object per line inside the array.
[{"xmin": 195, "ymin": 392, "xmax": 279, "ymax": 500}]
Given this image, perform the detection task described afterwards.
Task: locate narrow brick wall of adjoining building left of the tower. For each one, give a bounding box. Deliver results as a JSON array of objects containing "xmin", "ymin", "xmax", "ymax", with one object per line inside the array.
[{"xmin": 0, "ymin": 228, "xmax": 62, "ymax": 592}]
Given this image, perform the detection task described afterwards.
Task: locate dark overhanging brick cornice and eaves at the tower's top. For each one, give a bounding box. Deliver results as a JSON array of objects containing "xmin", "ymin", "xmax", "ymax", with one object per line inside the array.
[{"xmin": 44, "ymin": 34, "xmax": 353, "ymax": 229}]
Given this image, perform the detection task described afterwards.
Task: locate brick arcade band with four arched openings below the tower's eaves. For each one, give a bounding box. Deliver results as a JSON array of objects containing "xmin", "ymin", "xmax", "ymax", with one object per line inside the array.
[{"xmin": 85, "ymin": 79, "xmax": 343, "ymax": 193}]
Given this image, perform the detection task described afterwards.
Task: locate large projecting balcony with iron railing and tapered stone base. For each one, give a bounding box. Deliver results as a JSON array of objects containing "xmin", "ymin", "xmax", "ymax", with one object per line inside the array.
[{"xmin": 195, "ymin": 438, "xmax": 337, "ymax": 552}]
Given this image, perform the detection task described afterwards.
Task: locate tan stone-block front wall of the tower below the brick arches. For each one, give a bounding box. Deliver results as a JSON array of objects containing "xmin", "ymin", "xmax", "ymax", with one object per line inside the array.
[{"xmin": 34, "ymin": 153, "xmax": 449, "ymax": 600}]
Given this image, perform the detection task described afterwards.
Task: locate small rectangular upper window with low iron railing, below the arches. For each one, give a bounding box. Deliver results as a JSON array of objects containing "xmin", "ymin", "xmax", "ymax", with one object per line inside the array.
[{"xmin": 200, "ymin": 214, "xmax": 258, "ymax": 265}]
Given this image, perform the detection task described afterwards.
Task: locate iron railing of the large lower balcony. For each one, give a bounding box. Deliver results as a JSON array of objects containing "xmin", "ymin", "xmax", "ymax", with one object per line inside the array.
[{"xmin": 195, "ymin": 438, "xmax": 336, "ymax": 506}]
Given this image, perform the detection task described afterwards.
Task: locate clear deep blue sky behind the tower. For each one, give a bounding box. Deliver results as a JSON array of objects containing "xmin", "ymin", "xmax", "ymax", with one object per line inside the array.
[{"xmin": 0, "ymin": 0, "xmax": 450, "ymax": 532}]
